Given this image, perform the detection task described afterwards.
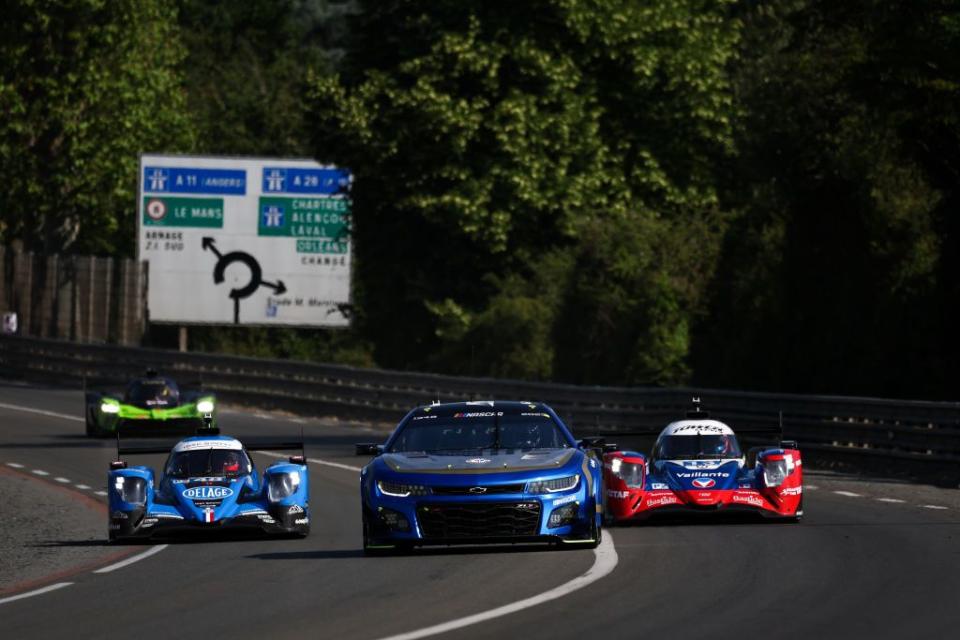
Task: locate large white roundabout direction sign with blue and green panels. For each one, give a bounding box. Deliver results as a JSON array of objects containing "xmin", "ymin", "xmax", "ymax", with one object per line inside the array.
[{"xmin": 137, "ymin": 154, "xmax": 352, "ymax": 327}]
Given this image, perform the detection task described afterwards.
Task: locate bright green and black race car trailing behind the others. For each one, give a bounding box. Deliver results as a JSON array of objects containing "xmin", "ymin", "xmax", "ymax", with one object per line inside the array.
[{"xmin": 84, "ymin": 370, "xmax": 216, "ymax": 437}]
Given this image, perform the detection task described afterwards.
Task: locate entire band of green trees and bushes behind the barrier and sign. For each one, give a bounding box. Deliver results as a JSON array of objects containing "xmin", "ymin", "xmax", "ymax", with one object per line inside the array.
[{"xmin": 0, "ymin": 0, "xmax": 960, "ymax": 397}]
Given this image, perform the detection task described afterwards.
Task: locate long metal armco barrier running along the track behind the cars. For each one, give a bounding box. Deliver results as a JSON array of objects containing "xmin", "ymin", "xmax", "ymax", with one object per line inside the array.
[{"xmin": 0, "ymin": 336, "xmax": 960, "ymax": 485}]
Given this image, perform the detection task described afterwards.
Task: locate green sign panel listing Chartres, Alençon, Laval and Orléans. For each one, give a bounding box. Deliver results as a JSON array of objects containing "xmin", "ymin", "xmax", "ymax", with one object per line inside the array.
[{"xmin": 257, "ymin": 197, "xmax": 348, "ymax": 248}]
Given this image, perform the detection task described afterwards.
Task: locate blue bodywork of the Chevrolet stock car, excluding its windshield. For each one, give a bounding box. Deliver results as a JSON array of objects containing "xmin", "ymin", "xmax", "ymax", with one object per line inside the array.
[{"xmin": 360, "ymin": 401, "xmax": 603, "ymax": 548}]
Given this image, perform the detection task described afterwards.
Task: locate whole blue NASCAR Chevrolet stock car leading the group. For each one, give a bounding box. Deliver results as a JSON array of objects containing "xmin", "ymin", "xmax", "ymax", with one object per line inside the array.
[{"xmin": 357, "ymin": 401, "xmax": 603, "ymax": 553}]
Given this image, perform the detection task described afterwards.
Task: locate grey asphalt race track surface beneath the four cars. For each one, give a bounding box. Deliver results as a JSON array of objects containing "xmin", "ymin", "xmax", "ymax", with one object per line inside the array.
[{"xmin": 0, "ymin": 382, "xmax": 960, "ymax": 640}]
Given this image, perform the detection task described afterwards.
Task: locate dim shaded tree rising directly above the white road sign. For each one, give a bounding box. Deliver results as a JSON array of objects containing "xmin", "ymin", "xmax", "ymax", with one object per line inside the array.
[{"xmin": 178, "ymin": 0, "xmax": 354, "ymax": 157}]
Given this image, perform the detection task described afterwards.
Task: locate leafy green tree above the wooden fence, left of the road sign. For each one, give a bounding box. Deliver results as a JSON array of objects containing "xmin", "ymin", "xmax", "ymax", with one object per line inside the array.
[{"xmin": 0, "ymin": 0, "xmax": 192, "ymax": 255}]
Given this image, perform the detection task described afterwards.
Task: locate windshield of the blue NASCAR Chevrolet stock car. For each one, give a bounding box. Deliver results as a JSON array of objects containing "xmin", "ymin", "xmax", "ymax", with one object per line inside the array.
[{"xmin": 387, "ymin": 407, "xmax": 570, "ymax": 455}]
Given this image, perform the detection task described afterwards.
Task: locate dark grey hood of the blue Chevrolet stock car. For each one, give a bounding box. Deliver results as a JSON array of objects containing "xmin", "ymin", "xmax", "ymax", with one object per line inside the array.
[{"xmin": 379, "ymin": 449, "xmax": 577, "ymax": 474}]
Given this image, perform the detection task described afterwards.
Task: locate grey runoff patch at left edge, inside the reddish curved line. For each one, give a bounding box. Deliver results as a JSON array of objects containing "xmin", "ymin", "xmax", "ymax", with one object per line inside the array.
[{"xmin": 0, "ymin": 465, "xmax": 118, "ymax": 597}]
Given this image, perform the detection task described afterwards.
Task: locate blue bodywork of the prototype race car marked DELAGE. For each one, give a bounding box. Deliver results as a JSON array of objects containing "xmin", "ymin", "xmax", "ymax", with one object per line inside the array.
[{"xmin": 107, "ymin": 436, "xmax": 310, "ymax": 540}]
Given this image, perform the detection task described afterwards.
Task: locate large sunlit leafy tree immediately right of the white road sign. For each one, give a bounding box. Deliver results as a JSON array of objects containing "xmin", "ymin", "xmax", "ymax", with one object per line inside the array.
[{"xmin": 313, "ymin": 0, "xmax": 738, "ymax": 382}]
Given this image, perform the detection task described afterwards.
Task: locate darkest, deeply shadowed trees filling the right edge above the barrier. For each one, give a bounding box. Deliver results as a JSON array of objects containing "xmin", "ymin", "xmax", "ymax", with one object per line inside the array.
[{"xmin": 694, "ymin": 0, "xmax": 960, "ymax": 395}]
